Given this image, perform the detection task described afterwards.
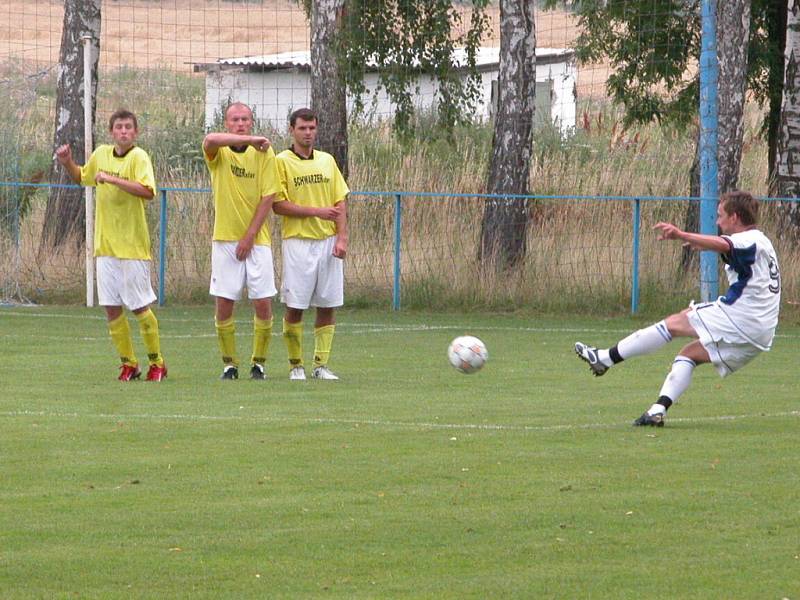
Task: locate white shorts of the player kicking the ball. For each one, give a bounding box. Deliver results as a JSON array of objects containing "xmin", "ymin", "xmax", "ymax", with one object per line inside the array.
[{"xmin": 687, "ymin": 302, "xmax": 763, "ymax": 377}]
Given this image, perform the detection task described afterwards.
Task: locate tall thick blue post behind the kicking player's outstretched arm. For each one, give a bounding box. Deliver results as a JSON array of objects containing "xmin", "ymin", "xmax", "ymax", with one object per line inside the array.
[{"xmin": 700, "ymin": 0, "xmax": 719, "ymax": 302}]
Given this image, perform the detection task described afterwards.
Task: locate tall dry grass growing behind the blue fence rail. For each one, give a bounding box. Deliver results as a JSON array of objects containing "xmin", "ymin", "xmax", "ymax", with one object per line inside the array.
[{"xmin": 0, "ymin": 64, "xmax": 800, "ymax": 312}]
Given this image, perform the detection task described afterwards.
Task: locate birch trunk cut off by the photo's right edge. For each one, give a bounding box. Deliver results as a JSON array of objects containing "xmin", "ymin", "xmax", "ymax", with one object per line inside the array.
[{"xmin": 777, "ymin": 0, "xmax": 800, "ymax": 240}]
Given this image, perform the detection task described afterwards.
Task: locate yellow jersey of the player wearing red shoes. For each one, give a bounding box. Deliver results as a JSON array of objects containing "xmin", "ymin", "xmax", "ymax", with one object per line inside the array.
[{"xmin": 81, "ymin": 144, "xmax": 156, "ymax": 260}]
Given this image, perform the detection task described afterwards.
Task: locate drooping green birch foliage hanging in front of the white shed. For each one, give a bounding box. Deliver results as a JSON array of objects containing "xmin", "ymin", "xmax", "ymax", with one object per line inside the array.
[{"xmin": 338, "ymin": 0, "xmax": 489, "ymax": 137}]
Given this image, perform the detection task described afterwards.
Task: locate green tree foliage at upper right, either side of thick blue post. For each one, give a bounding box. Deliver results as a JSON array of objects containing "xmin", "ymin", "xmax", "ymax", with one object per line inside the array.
[{"xmin": 544, "ymin": 0, "xmax": 785, "ymax": 127}]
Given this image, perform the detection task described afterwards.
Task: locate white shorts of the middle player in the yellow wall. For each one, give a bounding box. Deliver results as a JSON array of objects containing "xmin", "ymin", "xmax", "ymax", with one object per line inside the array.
[{"xmin": 208, "ymin": 242, "xmax": 277, "ymax": 300}]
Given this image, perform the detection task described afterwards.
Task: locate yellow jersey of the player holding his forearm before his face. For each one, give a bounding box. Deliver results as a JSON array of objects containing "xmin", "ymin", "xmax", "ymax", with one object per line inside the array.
[{"xmin": 203, "ymin": 146, "xmax": 281, "ymax": 246}]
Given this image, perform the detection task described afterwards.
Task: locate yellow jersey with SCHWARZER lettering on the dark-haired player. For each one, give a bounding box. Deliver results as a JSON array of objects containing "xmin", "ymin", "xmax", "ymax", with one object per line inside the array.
[{"xmin": 278, "ymin": 149, "xmax": 350, "ymax": 240}]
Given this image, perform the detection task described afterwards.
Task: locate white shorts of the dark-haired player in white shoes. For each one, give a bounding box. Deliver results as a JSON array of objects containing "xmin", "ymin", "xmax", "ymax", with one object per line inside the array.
[{"xmin": 281, "ymin": 235, "xmax": 344, "ymax": 310}]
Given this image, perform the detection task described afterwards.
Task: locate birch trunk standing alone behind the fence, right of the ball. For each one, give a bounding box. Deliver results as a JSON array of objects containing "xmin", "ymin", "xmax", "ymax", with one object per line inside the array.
[{"xmin": 480, "ymin": 0, "xmax": 536, "ymax": 268}]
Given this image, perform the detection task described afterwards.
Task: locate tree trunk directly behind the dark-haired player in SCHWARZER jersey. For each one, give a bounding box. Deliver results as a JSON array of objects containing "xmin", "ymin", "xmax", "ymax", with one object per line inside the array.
[{"xmin": 311, "ymin": 0, "xmax": 348, "ymax": 179}]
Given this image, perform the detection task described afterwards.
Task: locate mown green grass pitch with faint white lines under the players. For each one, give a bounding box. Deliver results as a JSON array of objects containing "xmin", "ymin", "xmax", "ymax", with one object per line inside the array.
[{"xmin": 0, "ymin": 307, "xmax": 800, "ymax": 599}]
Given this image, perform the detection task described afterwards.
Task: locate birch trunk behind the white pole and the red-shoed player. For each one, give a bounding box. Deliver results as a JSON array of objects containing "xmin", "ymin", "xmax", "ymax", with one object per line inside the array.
[{"xmin": 42, "ymin": 0, "xmax": 101, "ymax": 248}]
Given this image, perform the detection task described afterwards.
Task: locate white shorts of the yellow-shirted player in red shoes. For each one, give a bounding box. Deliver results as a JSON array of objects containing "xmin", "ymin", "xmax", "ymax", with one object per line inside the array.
[{"xmin": 96, "ymin": 256, "xmax": 157, "ymax": 310}]
